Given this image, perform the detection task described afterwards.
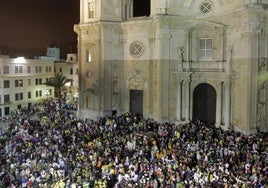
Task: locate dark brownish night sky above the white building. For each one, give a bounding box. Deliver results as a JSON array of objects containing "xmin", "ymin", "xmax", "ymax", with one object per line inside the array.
[{"xmin": 0, "ymin": 0, "xmax": 79, "ymax": 58}]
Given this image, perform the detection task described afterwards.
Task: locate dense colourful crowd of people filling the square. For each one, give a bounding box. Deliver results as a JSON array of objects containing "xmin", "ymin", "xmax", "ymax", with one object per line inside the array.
[{"xmin": 0, "ymin": 101, "xmax": 268, "ymax": 188}]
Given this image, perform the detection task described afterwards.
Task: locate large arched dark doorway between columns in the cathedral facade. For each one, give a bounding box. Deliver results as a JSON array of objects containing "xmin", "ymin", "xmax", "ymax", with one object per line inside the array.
[{"xmin": 193, "ymin": 83, "xmax": 216, "ymax": 124}]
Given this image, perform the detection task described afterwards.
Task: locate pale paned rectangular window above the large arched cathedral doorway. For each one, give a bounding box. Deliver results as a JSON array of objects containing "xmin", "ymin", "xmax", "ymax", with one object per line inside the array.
[{"xmin": 199, "ymin": 38, "xmax": 212, "ymax": 61}]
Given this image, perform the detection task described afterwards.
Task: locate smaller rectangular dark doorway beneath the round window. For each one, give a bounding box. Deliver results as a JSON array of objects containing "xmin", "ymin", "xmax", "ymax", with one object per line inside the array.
[{"xmin": 130, "ymin": 90, "xmax": 143, "ymax": 116}]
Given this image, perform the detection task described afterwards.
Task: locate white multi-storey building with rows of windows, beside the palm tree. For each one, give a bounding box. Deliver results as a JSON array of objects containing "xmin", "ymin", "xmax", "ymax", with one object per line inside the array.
[{"xmin": 0, "ymin": 56, "xmax": 54, "ymax": 118}]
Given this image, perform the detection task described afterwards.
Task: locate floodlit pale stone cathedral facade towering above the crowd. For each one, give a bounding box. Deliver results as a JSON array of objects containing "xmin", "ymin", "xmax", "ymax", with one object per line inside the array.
[{"xmin": 74, "ymin": 0, "xmax": 268, "ymax": 133}]
